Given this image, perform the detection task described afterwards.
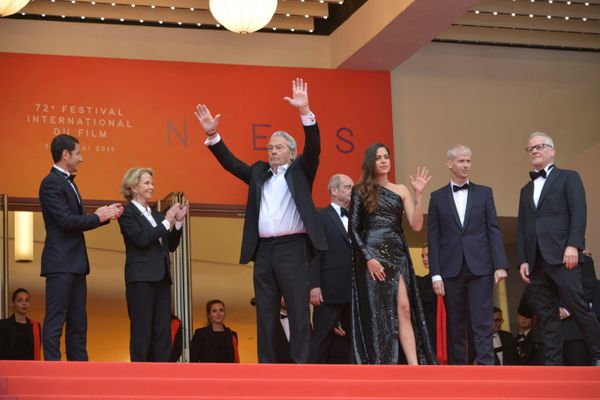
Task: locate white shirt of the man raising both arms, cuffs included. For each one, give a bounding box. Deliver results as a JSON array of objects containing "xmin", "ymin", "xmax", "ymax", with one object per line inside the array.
[{"xmin": 204, "ymin": 113, "xmax": 316, "ymax": 238}]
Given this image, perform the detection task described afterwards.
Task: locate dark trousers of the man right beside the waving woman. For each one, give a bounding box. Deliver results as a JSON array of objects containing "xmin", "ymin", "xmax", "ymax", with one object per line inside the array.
[{"xmin": 444, "ymin": 260, "xmax": 494, "ymax": 365}]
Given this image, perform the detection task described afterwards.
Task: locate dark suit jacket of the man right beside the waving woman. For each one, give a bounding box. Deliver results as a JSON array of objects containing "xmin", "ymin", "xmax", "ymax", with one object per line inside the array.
[{"xmin": 427, "ymin": 182, "xmax": 508, "ymax": 278}]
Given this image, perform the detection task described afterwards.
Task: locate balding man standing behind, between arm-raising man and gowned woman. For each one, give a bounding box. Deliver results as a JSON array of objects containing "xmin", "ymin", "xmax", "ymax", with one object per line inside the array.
[{"xmin": 309, "ymin": 174, "xmax": 354, "ymax": 364}]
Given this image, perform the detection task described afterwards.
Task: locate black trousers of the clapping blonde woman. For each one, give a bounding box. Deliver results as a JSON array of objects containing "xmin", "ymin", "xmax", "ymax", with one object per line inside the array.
[{"xmin": 125, "ymin": 278, "xmax": 171, "ymax": 362}]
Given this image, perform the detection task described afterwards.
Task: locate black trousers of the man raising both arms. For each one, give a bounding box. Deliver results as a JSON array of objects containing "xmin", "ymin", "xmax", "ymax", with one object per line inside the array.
[{"xmin": 254, "ymin": 234, "xmax": 311, "ymax": 363}]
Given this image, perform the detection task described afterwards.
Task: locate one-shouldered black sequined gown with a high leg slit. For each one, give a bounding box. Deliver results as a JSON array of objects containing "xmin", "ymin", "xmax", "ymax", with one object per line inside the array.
[{"xmin": 349, "ymin": 186, "xmax": 436, "ymax": 364}]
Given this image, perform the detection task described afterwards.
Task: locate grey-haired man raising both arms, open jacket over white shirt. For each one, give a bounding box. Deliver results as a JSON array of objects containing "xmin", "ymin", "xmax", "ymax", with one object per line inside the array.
[{"xmin": 196, "ymin": 79, "xmax": 327, "ymax": 363}]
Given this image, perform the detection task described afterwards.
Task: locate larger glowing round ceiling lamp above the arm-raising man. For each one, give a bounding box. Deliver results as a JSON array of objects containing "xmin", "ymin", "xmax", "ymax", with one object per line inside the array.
[{"xmin": 210, "ymin": 0, "xmax": 277, "ymax": 35}]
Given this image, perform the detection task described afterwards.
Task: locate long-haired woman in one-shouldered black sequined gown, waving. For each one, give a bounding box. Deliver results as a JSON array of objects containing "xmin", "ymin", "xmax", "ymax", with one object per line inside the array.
[{"xmin": 349, "ymin": 143, "xmax": 436, "ymax": 365}]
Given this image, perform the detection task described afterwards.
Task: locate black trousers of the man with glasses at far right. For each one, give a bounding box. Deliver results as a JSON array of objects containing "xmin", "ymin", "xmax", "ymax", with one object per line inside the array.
[{"xmin": 530, "ymin": 249, "xmax": 600, "ymax": 365}]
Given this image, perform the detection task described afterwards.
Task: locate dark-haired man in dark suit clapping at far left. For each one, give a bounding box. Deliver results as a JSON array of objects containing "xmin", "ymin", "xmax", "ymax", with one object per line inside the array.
[{"xmin": 39, "ymin": 134, "xmax": 123, "ymax": 361}]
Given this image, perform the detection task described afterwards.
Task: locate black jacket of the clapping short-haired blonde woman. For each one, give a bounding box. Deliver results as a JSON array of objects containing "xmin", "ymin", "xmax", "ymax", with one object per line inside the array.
[{"xmin": 119, "ymin": 203, "xmax": 181, "ymax": 283}]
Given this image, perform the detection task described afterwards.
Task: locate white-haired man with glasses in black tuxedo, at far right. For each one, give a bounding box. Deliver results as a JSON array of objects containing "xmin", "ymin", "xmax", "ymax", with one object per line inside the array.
[{"xmin": 517, "ymin": 132, "xmax": 600, "ymax": 366}]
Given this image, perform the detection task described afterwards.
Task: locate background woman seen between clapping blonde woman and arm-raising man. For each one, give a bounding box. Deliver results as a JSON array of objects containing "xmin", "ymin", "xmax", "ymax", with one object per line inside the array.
[{"xmin": 190, "ymin": 299, "xmax": 240, "ymax": 363}]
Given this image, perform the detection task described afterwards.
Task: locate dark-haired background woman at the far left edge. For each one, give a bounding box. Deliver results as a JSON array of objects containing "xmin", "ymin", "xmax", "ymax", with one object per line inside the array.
[{"xmin": 0, "ymin": 288, "xmax": 42, "ymax": 360}]
